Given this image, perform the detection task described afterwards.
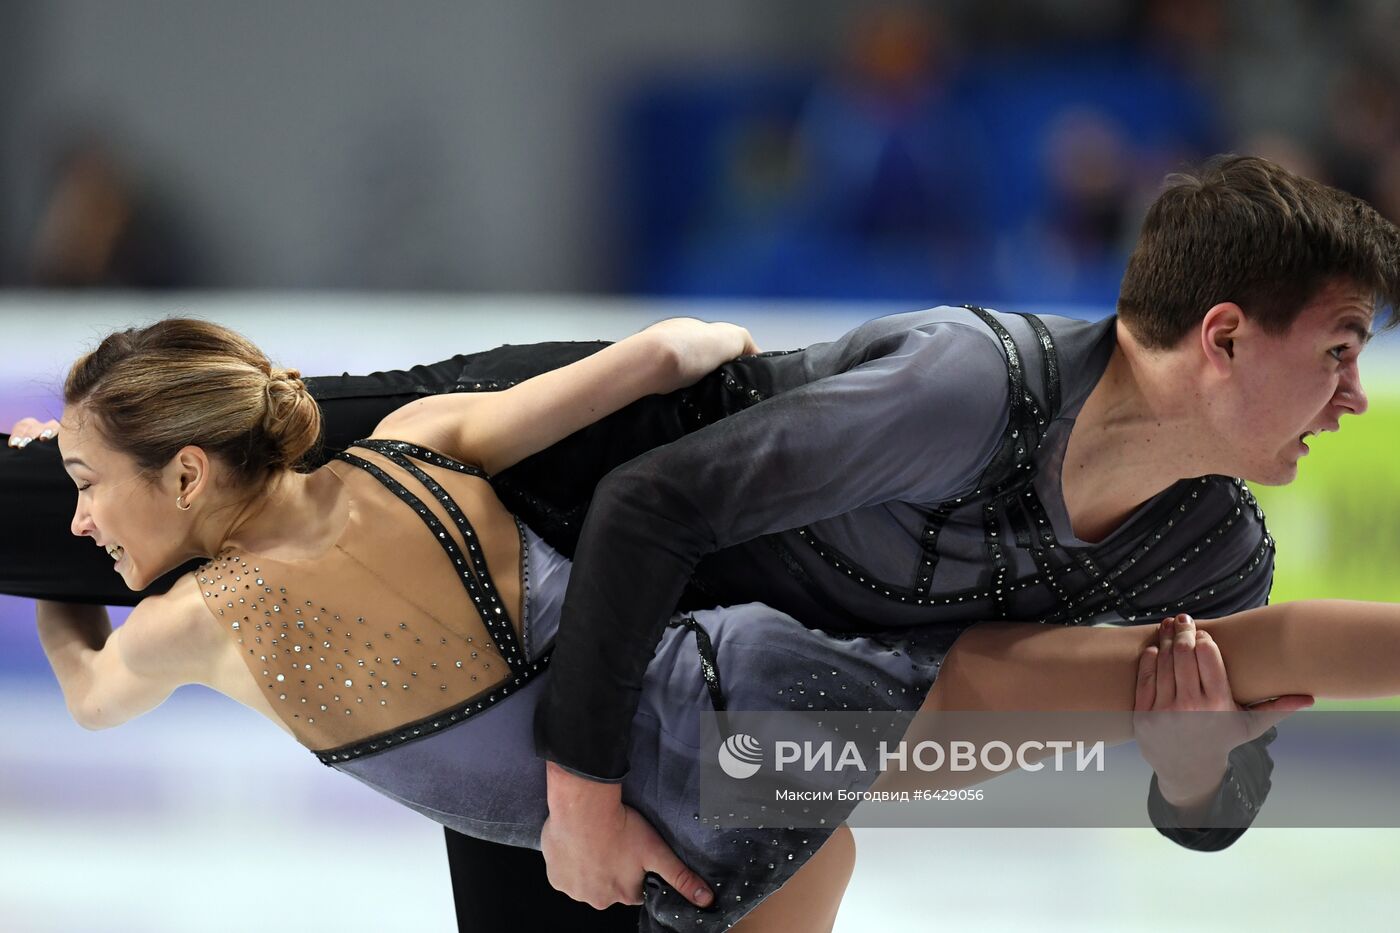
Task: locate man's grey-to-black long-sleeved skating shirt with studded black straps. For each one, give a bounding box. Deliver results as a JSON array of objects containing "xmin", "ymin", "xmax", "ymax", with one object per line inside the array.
[{"xmin": 536, "ymin": 307, "xmax": 1274, "ymax": 849}]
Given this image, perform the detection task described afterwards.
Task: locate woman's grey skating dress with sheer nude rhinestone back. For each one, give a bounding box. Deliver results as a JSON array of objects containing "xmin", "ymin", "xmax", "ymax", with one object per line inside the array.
[{"xmin": 197, "ymin": 440, "xmax": 967, "ymax": 930}]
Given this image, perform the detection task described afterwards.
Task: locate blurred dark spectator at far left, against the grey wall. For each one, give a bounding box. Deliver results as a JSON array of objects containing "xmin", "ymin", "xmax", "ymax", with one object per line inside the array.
[{"xmin": 27, "ymin": 137, "xmax": 196, "ymax": 289}]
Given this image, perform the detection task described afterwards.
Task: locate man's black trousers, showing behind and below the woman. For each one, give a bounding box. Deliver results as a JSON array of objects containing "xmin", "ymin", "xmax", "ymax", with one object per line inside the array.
[{"xmin": 0, "ymin": 343, "xmax": 756, "ymax": 933}]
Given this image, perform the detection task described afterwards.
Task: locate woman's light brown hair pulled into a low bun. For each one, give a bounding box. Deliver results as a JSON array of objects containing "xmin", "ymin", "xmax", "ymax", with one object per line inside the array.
[{"xmin": 63, "ymin": 318, "xmax": 321, "ymax": 488}]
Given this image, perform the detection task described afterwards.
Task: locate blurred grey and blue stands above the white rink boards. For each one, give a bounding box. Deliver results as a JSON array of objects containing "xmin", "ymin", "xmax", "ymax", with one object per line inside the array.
[{"xmin": 0, "ymin": 0, "xmax": 1400, "ymax": 305}]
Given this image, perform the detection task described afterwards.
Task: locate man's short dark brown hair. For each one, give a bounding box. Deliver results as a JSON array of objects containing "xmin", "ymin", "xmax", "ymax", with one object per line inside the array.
[{"xmin": 1119, "ymin": 156, "xmax": 1400, "ymax": 349}]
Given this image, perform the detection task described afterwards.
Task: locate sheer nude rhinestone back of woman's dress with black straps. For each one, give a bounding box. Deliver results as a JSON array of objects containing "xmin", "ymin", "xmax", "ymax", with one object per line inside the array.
[{"xmin": 197, "ymin": 441, "xmax": 543, "ymax": 763}]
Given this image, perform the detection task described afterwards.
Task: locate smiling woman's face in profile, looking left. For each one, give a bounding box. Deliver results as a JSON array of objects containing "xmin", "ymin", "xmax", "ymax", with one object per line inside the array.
[{"xmin": 59, "ymin": 406, "xmax": 189, "ymax": 590}]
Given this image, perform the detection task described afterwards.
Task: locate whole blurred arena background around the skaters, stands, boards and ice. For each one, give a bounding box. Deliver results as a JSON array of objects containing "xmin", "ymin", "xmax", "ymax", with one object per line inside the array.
[{"xmin": 0, "ymin": 0, "xmax": 1400, "ymax": 933}]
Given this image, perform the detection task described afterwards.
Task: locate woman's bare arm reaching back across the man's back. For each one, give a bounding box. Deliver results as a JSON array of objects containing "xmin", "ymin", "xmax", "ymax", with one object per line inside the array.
[{"xmin": 375, "ymin": 318, "xmax": 757, "ymax": 474}]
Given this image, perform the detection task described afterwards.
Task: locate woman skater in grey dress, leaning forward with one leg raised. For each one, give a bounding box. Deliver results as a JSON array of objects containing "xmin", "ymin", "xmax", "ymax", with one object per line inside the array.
[{"xmin": 39, "ymin": 319, "xmax": 1400, "ymax": 930}]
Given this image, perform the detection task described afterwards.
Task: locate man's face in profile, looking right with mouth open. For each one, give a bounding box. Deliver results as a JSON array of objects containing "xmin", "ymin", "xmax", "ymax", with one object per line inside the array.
[{"xmin": 1228, "ymin": 283, "xmax": 1375, "ymax": 486}]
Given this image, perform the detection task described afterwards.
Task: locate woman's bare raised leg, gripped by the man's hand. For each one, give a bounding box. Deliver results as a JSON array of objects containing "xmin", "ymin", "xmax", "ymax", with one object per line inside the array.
[{"xmin": 924, "ymin": 600, "xmax": 1400, "ymax": 712}]
